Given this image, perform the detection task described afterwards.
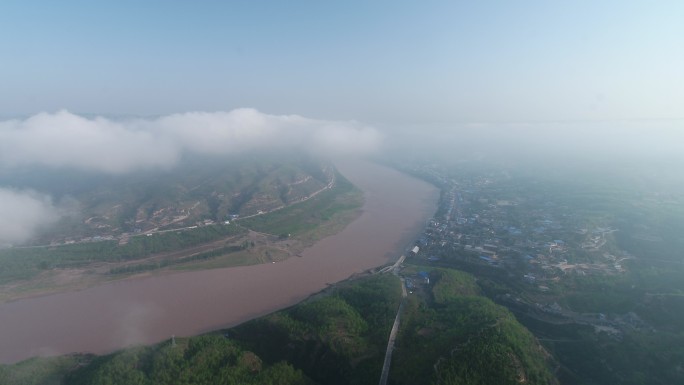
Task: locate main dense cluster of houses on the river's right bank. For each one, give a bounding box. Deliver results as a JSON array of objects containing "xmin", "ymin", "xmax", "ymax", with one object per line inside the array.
[{"xmin": 400, "ymin": 166, "xmax": 628, "ymax": 291}]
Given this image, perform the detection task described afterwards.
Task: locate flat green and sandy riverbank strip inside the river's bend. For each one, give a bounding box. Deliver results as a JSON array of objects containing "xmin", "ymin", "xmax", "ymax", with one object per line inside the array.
[{"xmin": 0, "ymin": 170, "xmax": 363, "ymax": 303}]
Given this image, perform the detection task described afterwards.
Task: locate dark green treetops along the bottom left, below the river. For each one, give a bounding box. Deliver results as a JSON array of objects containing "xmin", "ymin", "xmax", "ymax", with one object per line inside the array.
[{"xmin": 0, "ymin": 335, "xmax": 313, "ymax": 385}]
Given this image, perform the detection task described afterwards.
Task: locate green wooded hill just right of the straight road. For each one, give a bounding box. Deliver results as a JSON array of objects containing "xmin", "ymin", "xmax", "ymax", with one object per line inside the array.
[{"xmin": 390, "ymin": 269, "xmax": 557, "ymax": 384}]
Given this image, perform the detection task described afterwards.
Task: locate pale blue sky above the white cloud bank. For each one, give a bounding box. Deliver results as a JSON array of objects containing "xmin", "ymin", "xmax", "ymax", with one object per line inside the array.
[{"xmin": 0, "ymin": 0, "xmax": 684, "ymax": 124}]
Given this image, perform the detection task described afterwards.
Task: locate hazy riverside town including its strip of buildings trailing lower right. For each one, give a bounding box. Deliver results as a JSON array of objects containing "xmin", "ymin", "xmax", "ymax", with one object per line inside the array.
[{"xmin": 392, "ymin": 162, "xmax": 649, "ymax": 339}]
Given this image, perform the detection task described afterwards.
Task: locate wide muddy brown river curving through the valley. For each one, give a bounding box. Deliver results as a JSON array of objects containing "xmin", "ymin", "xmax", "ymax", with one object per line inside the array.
[{"xmin": 0, "ymin": 161, "xmax": 439, "ymax": 363}]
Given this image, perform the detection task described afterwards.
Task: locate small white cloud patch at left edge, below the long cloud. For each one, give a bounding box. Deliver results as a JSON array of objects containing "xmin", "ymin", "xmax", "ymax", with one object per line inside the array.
[{"xmin": 0, "ymin": 188, "xmax": 60, "ymax": 246}]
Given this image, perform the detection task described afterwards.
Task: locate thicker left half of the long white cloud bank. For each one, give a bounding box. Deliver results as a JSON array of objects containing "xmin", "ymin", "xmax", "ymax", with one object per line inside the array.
[{"xmin": 0, "ymin": 111, "xmax": 178, "ymax": 173}]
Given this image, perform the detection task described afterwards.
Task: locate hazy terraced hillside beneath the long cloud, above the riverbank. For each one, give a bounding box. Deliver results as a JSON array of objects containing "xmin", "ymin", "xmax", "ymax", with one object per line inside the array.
[{"xmin": 0, "ymin": 154, "xmax": 333, "ymax": 245}]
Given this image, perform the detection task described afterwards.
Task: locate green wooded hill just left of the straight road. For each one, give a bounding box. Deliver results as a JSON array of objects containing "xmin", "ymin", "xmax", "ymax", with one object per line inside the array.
[{"xmin": 229, "ymin": 276, "xmax": 401, "ymax": 384}]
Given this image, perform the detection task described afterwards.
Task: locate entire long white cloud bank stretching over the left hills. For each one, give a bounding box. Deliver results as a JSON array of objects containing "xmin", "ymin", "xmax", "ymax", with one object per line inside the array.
[{"xmin": 0, "ymin": 109, "xmax": 380, "ymax": 173}]
